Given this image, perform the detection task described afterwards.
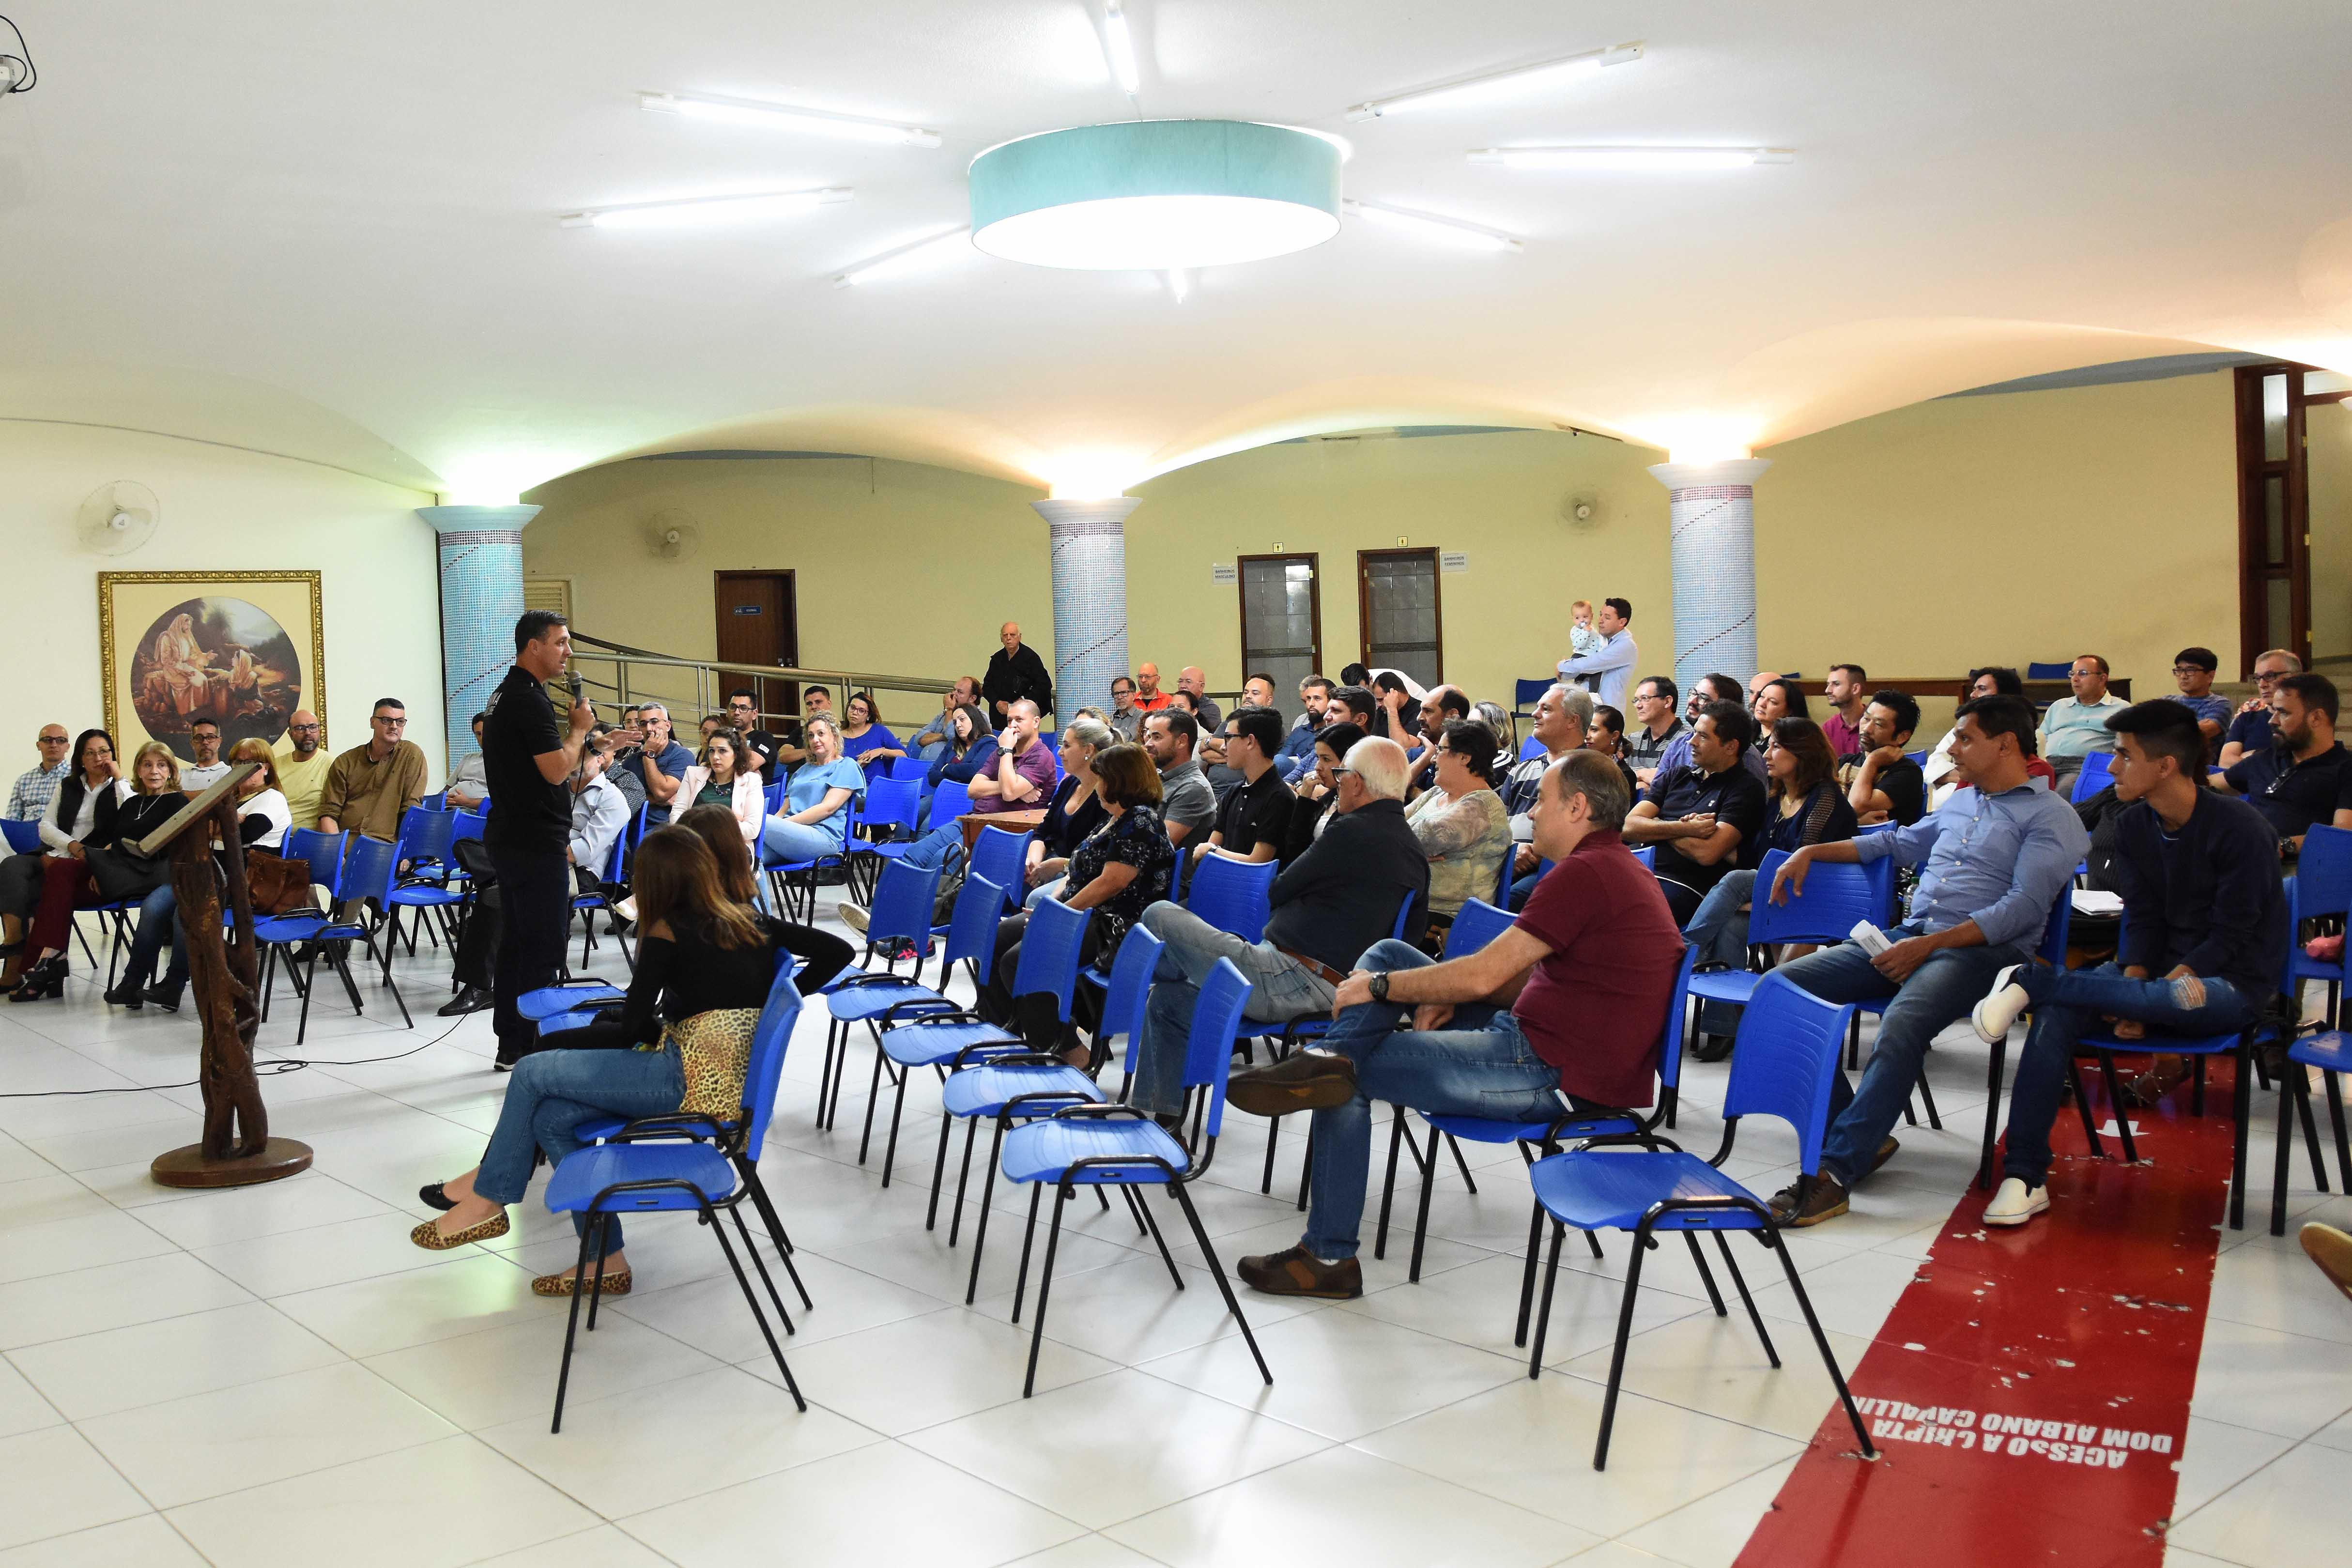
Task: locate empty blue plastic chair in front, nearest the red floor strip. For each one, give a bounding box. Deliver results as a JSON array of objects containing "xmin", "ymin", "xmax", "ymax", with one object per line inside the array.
[{"xmin": 1526, "ymin": 976, "xmax": 1877, "ymax": 1469}]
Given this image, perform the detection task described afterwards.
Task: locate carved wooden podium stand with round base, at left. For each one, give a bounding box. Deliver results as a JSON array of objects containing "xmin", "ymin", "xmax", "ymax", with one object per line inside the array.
[{"xmin": 134, "ymin": 762, "xmax": 310, "ymax": 1187}]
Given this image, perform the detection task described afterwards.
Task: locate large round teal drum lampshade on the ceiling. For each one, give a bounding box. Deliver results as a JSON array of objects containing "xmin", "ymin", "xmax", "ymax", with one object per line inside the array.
[{"xmin": 971, "ymin": 120, "xmax": 1340, "ymax": 270}]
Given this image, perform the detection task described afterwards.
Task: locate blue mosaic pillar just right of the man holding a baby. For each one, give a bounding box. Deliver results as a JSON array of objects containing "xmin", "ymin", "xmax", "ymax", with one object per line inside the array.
[{"xmin": 1649, "ymin": 459, "xmax": 1771, "ymax": 691}]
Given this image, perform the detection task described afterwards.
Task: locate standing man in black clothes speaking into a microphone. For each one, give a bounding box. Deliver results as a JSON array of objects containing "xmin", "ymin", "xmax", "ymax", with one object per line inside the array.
[{"xmin": 482, "ymin": 609, "xmax": 595, "ymax": 1072}]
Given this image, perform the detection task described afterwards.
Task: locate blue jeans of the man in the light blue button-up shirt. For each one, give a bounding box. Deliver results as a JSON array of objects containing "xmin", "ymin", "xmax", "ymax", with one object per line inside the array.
[{"xmin": 1773, "ymin": 924, "xmax": 2028, "ymax": 1187}]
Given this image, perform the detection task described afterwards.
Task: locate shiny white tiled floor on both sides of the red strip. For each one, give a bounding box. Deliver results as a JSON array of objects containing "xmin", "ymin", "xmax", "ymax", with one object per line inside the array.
[{"xmin": 0, "ymin": 912, "xmax": 2352, "ymax": 1568}]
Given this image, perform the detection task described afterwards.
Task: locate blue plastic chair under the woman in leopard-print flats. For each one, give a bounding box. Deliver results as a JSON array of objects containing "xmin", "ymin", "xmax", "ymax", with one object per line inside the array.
[{"xmin": 548, "ymin": 966, "xmax": 809, "ymax": 1431}]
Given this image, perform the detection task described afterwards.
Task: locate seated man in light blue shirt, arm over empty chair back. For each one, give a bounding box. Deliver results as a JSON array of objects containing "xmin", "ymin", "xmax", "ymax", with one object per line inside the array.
[{"xmin": 1771, "ymin": 693, "xmax": 2091, "ymax": 1225}]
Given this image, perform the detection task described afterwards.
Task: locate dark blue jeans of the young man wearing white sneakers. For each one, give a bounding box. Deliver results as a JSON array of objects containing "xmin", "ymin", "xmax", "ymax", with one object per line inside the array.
[{"xmin": 2001, "ymin": 964, "xmax": 2258, "ymax": 1187}]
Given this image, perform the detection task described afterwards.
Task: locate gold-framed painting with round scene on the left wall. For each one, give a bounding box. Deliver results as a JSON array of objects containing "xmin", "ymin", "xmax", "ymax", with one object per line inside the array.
[{"xmin": 99, "ymin": 571, "xmax": 327, "ymax": 762}]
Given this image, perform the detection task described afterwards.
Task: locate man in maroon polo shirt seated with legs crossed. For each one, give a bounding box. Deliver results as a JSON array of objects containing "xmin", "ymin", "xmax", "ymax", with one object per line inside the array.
[{"xmin": 1230, "ymin": 750, "xmax": 1684, "ymax": 1300}]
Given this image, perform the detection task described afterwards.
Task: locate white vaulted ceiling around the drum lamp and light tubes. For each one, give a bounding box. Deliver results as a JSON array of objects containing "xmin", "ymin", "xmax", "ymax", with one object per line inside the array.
[{"xmin": 0, "ymin": 0, "xmax": 2352, "ymax": 498}]
